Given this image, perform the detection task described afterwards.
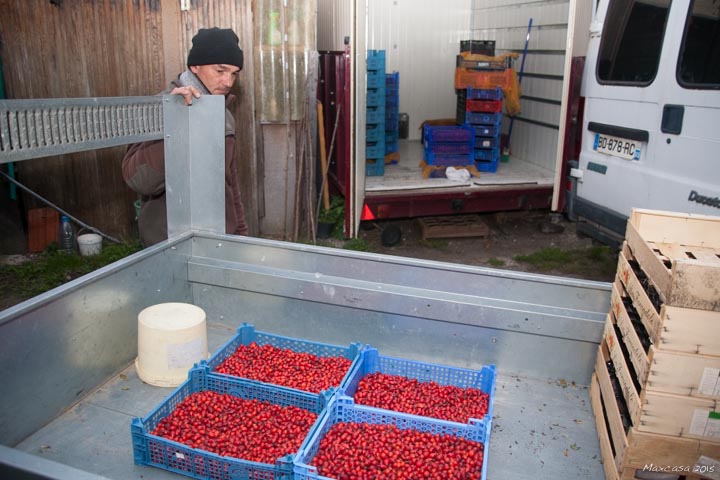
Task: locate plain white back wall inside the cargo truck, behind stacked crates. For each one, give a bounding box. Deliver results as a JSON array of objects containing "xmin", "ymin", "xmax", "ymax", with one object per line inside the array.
[{"xmin": 368, "ymin": 0, "xmax": 472, "ymax": 139}]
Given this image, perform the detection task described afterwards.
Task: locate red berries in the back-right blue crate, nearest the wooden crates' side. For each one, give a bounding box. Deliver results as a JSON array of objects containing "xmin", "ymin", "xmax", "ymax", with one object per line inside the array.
[{"xmin": 354, "ymin": 372, "xmax": 489, "ymax": 423}]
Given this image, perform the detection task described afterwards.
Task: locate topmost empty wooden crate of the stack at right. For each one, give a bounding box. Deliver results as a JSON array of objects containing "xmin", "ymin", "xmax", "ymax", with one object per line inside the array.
[{"xmin": 625, "ymin": 209, "xmax": 720, "ymax": 311}]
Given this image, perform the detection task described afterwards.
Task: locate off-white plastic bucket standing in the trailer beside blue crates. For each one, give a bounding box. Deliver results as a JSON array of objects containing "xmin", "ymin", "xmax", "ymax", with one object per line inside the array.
[{"xmin": 135, "ymin": 303, "xmax": 208, "ymax": 387}]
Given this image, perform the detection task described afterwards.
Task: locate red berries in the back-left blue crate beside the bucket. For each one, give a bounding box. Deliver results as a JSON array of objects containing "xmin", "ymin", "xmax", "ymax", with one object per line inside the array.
[{"xmin": 215, "ymin": 342, "xmax": 352, "ymax": 393}]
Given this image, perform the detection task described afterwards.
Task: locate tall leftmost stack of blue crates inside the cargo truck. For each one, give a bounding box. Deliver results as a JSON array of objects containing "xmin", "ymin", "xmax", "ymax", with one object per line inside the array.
[{"xmin": 365, "ymin": 50, "xmax": 386, "ymax": 176}]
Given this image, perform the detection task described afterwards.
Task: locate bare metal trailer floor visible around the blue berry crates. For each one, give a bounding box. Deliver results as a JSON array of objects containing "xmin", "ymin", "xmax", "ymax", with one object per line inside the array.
[{"xmin": 16, "ymin": 320, "xmax": 604, "ymax": 480}]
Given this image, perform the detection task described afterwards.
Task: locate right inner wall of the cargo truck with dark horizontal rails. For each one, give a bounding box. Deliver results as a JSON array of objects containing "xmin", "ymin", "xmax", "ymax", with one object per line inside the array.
[{"xmin": 472, "ymin": 0, "xmax": 569, "ymax": 170}]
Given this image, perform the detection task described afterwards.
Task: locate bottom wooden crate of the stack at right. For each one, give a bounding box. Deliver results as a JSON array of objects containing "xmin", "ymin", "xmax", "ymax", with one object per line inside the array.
[{"xmin": 590, "ymin": 350, "xmax": 720, "ymax": 480}]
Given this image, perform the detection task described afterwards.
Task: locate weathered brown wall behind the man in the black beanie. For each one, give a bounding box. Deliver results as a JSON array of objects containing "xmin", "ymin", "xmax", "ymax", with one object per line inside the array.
[{"xmin": 0, "ymin": 0, "xmax": 258, "ymax": 244}]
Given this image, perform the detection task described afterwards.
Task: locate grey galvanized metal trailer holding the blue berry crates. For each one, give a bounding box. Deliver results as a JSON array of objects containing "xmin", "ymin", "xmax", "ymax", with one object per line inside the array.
[{"xmin": 0, "ymin": 97, "xmax": 610, "ymax": 480}]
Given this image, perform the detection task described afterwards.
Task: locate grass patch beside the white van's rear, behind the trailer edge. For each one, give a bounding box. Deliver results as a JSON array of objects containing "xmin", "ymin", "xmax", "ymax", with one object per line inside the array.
[{"xmin": 514, "ymin": 245, "xmax": 617, "ymax": 279}]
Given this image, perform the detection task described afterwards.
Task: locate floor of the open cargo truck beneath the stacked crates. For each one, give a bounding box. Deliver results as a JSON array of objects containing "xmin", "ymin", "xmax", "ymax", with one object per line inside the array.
[{"xmin": 365, "ymin": 140, "xmax": 555, "ymax": 196}]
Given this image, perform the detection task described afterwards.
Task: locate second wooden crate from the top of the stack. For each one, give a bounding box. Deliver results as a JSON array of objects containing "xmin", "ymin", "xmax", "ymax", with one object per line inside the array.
[{"xmin": 617, "ymin": 243, "xmax": 720, "ymax": 355}]
